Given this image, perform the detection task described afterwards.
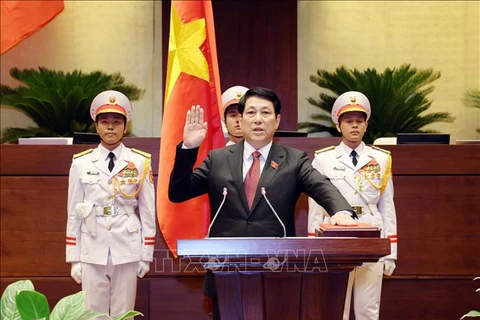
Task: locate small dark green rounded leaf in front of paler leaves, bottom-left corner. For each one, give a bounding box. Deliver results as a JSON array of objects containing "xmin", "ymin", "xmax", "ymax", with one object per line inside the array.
[{"xmin": 15, "ymin": 290, "xmax": 50, "ymax": 320}]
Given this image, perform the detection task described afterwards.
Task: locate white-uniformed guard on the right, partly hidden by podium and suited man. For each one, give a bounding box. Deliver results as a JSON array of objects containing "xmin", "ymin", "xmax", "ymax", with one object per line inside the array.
[{"xmin": 308, "ymin": 91, "xmax": 397, "ymax": 320}]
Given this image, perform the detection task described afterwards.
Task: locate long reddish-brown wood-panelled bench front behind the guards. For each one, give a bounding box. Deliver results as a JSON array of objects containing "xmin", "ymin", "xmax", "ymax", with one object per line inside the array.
[{"xmin": 0, "ymin": 138, "xmax": 480, "ymax": 319}]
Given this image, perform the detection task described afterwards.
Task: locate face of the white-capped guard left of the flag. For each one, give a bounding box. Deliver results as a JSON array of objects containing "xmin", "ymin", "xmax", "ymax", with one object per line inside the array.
[{"xmin": 95, "ymin": 113, "xmax": 127, "ymax": 150}]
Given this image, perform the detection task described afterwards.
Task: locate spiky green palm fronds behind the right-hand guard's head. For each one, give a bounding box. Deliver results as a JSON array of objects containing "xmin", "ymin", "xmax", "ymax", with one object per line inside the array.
[{"xmin": 298, "ymin": 64, "xmax": 455, "ymax": 143}]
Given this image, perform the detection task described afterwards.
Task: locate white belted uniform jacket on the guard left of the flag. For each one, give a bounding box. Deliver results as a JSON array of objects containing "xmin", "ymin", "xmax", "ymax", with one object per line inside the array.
[{"xmin": 66, "ymin": 144, "xmax": 156, "ymax": 265}]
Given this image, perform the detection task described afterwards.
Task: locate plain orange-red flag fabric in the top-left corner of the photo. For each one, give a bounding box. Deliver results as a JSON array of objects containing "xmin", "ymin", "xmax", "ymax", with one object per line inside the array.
[{"xmin": 0, "ymin": 0, "xmax": 64, "ymax": 54}]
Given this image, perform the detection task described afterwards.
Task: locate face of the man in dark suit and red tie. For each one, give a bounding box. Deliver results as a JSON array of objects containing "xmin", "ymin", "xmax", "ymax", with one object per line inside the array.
[{"xmin": 240, "ymin": 96, "xmax": 280, "ymax": 149}]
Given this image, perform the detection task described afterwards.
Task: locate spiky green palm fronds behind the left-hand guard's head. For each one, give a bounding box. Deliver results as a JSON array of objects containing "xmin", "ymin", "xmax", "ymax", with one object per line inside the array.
[{"xmin": 0, "ymin": 67, "xmax": 144, "ymax": 143}]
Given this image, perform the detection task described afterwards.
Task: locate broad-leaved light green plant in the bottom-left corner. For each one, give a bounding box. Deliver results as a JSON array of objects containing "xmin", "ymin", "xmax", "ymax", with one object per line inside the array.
[{"xmin": 0, "ymin": 280, "xmax": 143, "ymax": 320}]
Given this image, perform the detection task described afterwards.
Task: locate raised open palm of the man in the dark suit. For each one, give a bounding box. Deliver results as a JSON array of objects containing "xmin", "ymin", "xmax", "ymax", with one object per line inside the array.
[{"xmin": 183, "ymin": 105, "xmax": 207, "ymax": 148}]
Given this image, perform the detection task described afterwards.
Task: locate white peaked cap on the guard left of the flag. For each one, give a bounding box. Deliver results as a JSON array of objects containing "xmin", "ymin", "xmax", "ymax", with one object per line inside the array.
[{"xmin": 90, "ymin": 90, "xmax": 133, "ymax": 122}]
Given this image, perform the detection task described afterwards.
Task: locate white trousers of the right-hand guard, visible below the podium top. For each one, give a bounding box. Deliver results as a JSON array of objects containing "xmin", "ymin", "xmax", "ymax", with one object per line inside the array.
[{"xmin": 343, "ymin": 261, "xmax": 383, "ymax": 320}]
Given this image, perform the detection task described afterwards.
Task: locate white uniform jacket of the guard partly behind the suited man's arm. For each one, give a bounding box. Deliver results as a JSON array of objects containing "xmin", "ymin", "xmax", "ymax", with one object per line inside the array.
[{"xmin": 308, "ymin": 142, "xmax": 397, "ymax": 259}]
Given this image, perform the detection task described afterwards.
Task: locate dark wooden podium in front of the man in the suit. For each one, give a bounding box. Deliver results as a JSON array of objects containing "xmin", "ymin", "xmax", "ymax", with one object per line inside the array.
[{"xmin": 178, "ymin": 238, "xmax": 390, "ymax": 320}]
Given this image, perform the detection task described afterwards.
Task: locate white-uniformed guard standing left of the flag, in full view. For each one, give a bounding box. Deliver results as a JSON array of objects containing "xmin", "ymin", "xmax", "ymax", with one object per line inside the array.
[{"xmin": 66, "ymin": 90, "xmax": 156, "ymax": 319}]
